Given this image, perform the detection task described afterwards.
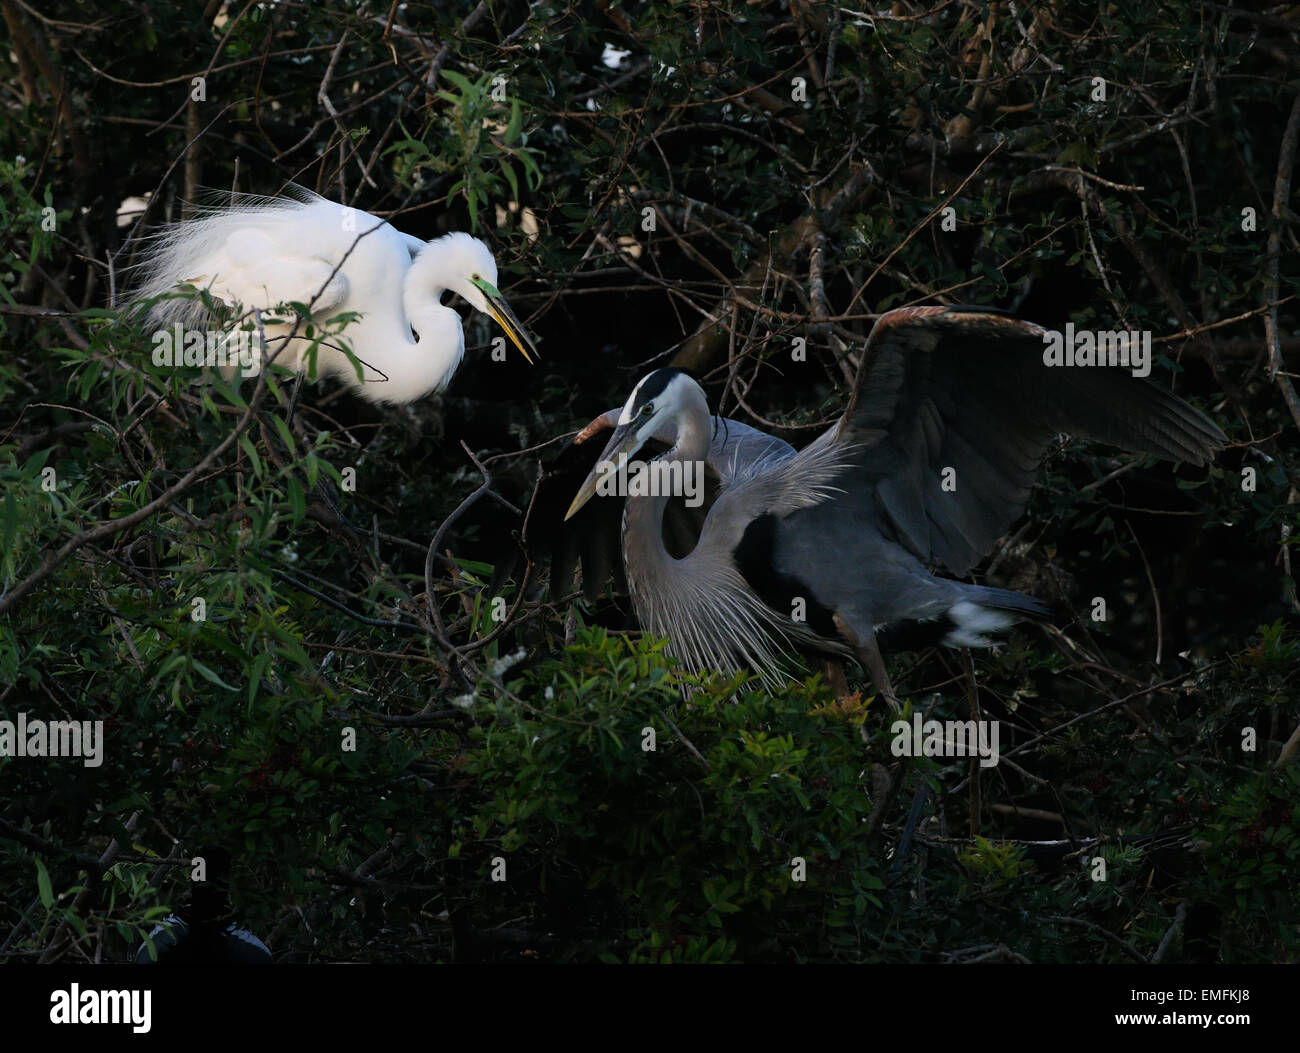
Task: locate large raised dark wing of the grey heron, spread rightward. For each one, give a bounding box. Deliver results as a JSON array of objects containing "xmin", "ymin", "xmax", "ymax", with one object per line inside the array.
[{"xmin": 814, "ymin": 307, "xmax": 1225, "ymax": 575}]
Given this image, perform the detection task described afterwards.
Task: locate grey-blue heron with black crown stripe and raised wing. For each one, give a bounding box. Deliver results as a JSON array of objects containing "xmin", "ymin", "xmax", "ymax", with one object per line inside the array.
[{"xmin": 553, "ymin": 307, "xmax": 1225, "ymax": 703}]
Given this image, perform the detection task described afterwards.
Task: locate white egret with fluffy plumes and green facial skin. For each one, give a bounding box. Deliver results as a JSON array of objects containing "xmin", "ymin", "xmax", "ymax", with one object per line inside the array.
[{"xmin": 133, "ymin": 187, "xmax": 536, "ymax": 403}]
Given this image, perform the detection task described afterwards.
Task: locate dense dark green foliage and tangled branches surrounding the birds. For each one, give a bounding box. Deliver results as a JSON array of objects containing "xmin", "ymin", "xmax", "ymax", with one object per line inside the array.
[{"xmin": 0, "ymin": 0, "xmax": 1300, "ymax": 962}]
